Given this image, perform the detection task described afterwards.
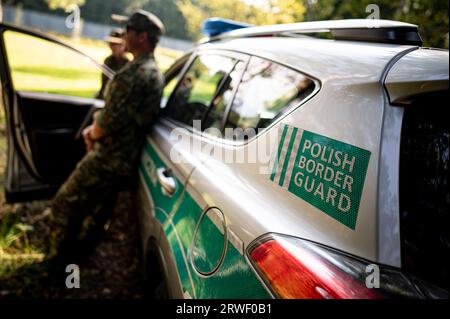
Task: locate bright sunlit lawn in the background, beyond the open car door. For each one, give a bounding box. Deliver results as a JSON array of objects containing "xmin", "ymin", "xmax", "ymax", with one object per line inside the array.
[{"xmin": 5, "ymin": 31, "xmax": 182, "ymax": 97}]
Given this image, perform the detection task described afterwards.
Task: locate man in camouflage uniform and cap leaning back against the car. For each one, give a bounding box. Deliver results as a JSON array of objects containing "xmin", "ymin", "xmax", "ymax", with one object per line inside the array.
[{"xmin": 52, "ymin": 10, "xmax": 164, "ymax": 265}]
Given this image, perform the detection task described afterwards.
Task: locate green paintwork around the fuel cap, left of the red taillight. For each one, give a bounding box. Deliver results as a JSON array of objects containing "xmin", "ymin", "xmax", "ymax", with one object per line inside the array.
[{"xmin": 164, "ymin": 192, "xmax": 271, "ymax": 299}]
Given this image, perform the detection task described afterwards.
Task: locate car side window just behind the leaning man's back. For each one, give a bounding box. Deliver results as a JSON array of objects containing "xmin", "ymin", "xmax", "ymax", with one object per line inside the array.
[{"xmin": 164, "ymin": 54, "xmax": 237, "ymax": 126}]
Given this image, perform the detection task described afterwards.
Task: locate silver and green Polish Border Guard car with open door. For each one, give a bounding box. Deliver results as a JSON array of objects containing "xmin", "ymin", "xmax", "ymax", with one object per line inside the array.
[{"xmin": 1, "ymin": 19, "xmax": 450, "ymax": 299}]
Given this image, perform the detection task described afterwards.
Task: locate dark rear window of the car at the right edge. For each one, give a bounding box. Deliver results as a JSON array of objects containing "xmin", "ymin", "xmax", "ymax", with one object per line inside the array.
[{"xmin": 400, "ymin": 91, "xmax": 450, "ymax": 291}]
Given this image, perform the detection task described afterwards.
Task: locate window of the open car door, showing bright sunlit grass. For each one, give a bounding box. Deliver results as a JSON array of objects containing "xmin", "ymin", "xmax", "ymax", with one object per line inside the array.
[{"xmin": 4, "ymin": 31, "xmax": 102, "ymax": 98}]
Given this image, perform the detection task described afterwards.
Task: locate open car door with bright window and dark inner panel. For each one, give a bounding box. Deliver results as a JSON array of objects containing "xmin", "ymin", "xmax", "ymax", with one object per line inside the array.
[{"xmin": 0, "ymin": 24, "xmax": 113, "ymax": 203}]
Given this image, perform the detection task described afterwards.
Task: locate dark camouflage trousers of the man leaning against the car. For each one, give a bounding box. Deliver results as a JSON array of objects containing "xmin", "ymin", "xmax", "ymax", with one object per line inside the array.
[{"xmin": 50, "ymin": 151, "xmax": 131, "ymax": 263}]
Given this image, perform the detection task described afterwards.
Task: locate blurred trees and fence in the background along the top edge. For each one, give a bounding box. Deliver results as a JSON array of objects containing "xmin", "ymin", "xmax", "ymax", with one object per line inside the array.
[{"xmin": 3, "ymin": 0, "xmax": 449, "ymax": 48}]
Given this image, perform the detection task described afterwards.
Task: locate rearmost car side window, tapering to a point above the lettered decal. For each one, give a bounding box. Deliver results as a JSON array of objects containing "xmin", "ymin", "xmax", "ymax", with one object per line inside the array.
[{"xmin": 225, "ymin": 57, "xmax": 315, "ymax": 140}]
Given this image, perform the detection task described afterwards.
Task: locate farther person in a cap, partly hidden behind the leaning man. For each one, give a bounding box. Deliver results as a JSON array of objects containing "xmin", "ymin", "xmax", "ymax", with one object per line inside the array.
[{"xmin": 96, "ymin": 29, "xmax": 130, "ymax": 99}]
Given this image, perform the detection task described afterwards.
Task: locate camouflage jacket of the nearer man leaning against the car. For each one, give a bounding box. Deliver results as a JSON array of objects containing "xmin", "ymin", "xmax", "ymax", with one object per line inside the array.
[{"xmin": 94, "ymin": 54, "xmax": 164, "ymax": 175}]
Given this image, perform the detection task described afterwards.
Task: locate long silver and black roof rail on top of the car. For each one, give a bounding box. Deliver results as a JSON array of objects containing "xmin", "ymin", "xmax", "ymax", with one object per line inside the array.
[{"xmin": 204, "ymin": 19, "xmax": 422, "ymax": 46}]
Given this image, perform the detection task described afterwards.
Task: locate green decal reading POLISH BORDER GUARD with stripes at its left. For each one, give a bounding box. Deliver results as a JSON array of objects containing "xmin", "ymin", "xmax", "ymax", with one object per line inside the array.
[{"xmin": 271, "ymin": 125, "xmax": 370, "ymax": 230}]
